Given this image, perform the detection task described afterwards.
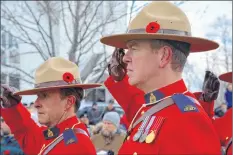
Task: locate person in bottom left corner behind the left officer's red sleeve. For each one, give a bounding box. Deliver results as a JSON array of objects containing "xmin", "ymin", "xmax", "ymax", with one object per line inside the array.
[{"xmin": 0, "ymin": 117, "xmax": 24, "ymax": 155}]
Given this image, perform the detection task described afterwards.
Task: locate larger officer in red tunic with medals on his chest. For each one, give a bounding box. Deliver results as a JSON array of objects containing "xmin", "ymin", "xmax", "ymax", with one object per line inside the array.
[{"xmin": 101, "ymin": 1, "xmax": 221, "ymax": 155}]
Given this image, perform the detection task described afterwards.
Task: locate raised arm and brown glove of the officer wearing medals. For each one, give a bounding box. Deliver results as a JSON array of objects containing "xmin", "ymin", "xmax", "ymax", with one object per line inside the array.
[{"xmin": 104, "ymin": 48, "xmax": 144, "ymax": 122}]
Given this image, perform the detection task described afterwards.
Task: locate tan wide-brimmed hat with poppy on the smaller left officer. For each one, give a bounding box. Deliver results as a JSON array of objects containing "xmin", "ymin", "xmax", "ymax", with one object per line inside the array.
[{"xmin": 15, "ymin": 57, "xmax": 102, "ymax": 95}]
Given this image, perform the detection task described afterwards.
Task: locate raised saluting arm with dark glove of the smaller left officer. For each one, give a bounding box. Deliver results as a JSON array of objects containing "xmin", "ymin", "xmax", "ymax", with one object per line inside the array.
[{"xmin": 1, "ymin": 85, "xmax": 43, "ymax": 154}]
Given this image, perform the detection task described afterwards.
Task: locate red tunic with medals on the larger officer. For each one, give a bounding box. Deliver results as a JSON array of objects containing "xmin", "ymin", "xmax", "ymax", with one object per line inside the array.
[{"xmin": 105, "ymin": 77, "xmax": 221, "ymax": 155}]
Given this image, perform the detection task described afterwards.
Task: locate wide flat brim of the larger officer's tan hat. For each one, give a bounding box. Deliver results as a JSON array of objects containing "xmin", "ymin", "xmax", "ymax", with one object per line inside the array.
[{"xmin": 100, "ymin": 33, "xmax": 219, "ymax": 52}]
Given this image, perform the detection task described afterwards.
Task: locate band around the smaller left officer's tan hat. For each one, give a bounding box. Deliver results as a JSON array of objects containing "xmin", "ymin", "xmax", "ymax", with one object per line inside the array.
[{"xmin": 35, "ymin": 79, "xmax": 82, "ymax": 88}]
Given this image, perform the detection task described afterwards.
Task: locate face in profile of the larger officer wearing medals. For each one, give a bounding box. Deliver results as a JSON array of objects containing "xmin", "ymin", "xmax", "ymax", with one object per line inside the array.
[{"xmin": 123, "ymin": 40, "xmax": 160, "ymax": 88}]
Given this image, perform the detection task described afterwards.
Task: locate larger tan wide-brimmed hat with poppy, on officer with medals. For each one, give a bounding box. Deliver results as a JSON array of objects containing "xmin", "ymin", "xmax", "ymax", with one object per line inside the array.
[{"xmin": 100, "ymin": 1, "xmax": 219, "ymax": 52}]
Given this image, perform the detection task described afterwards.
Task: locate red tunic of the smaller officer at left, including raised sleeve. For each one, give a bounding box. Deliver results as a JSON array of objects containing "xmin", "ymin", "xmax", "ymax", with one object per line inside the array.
[{"xmin": 1, "ymin": 103, "xmax": 96, "ymax": 155}]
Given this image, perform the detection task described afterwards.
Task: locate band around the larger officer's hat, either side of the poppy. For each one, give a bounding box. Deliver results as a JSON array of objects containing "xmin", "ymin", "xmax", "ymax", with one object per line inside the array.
[{"xmin": 128, "ymin": 29, "xmax": 191, "ymax": 37}]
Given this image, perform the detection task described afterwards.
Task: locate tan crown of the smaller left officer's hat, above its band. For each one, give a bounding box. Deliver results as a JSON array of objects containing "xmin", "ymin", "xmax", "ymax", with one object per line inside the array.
[{"xmin": 35, "ymin": 57, "xmax": 80, "ymax": 84}]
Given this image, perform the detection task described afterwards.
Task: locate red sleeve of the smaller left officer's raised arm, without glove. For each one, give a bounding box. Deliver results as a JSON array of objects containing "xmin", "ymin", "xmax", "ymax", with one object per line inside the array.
[{"xmin": 1, "ymin": 103, "xmax": 43, "ymax": 154}]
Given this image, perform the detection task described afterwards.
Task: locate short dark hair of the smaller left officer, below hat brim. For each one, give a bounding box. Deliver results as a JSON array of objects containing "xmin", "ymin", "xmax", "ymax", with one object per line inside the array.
[{"xmin": 60, "ymin": 88, "xmax": 84, "ymax": 112}]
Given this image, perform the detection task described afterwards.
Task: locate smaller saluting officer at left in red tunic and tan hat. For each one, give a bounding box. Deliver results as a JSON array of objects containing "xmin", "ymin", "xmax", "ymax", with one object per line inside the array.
[{"xmin": 1, "ymin": 57, "xmax": 100, "ymax": 155}]
